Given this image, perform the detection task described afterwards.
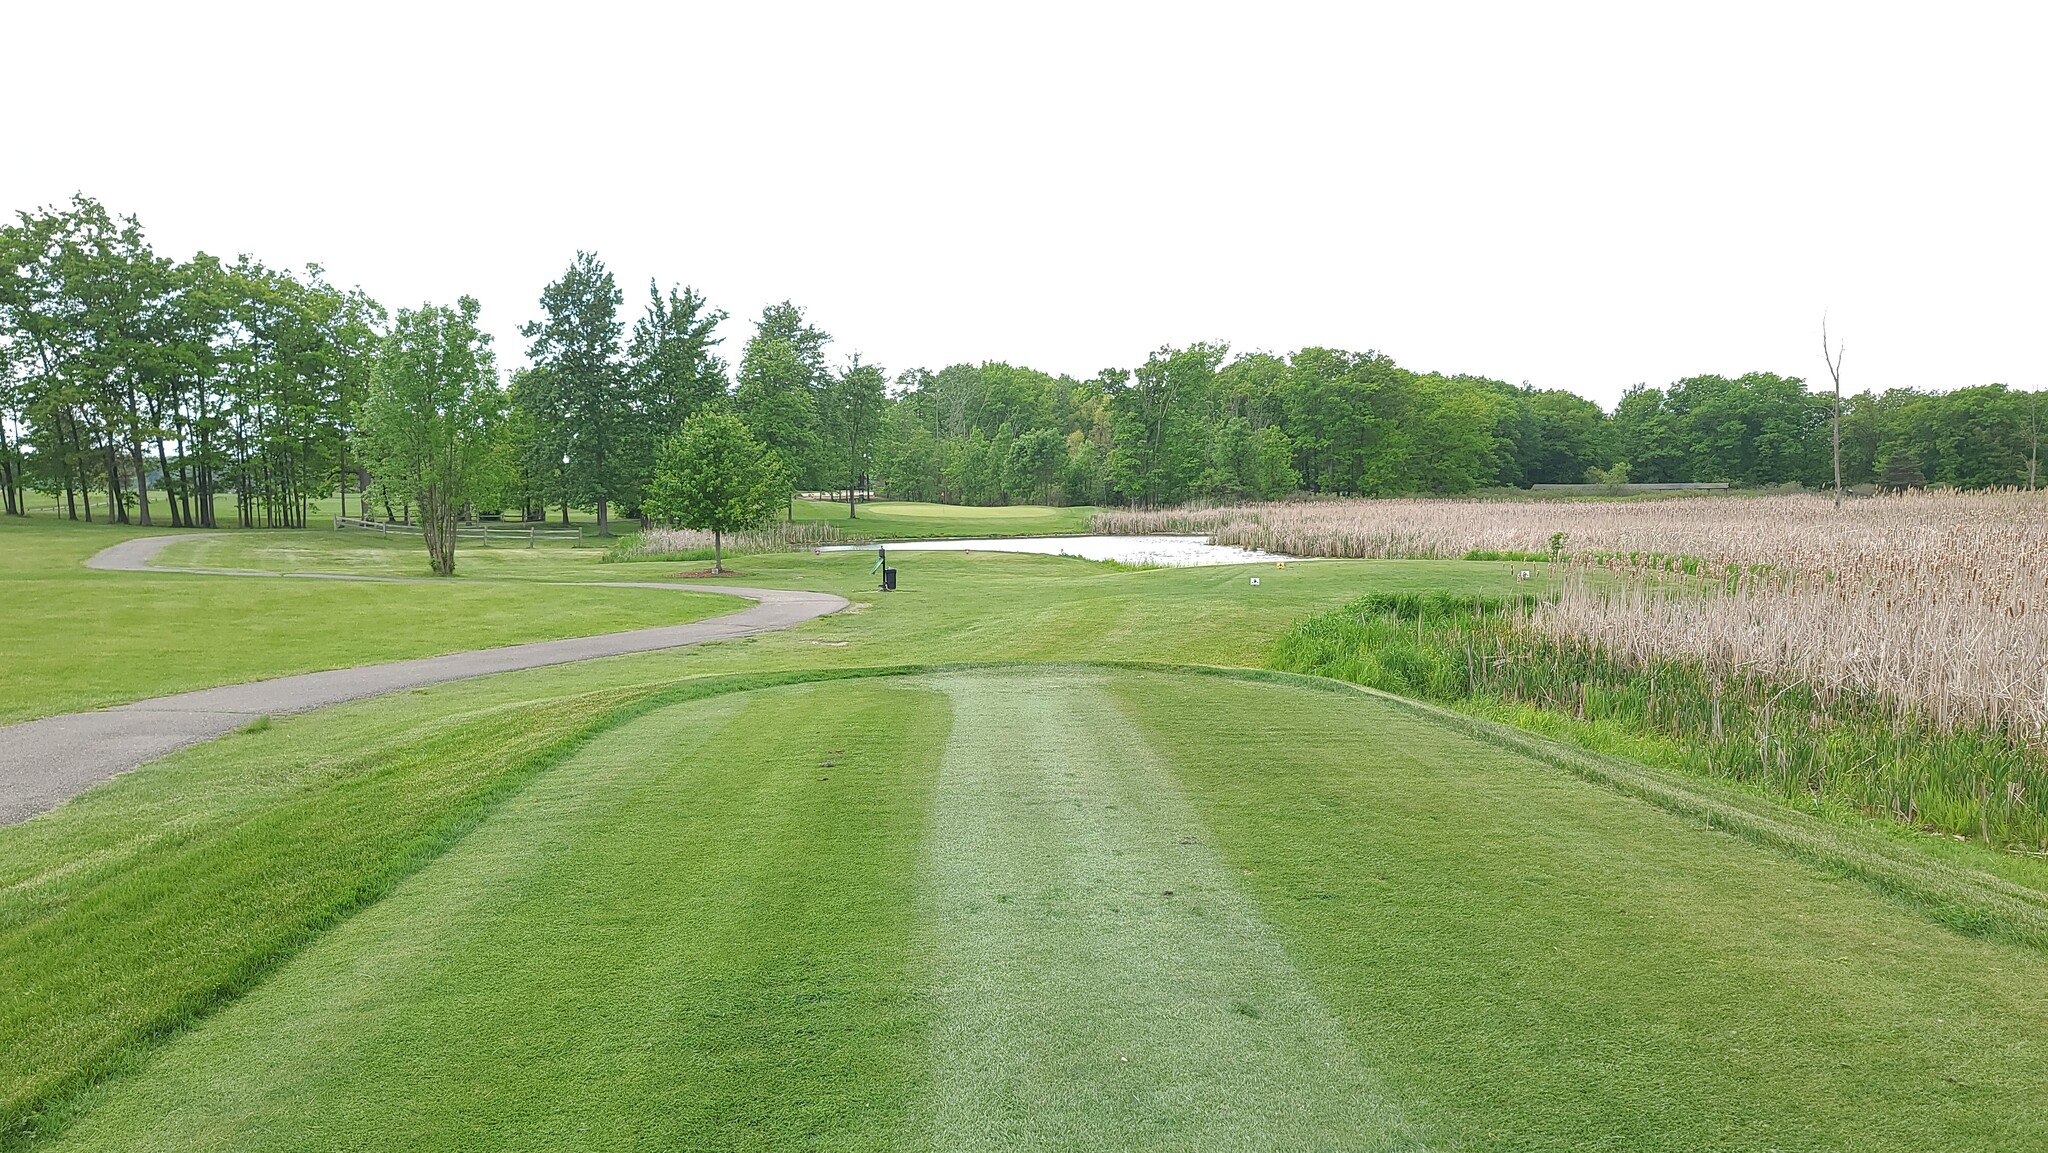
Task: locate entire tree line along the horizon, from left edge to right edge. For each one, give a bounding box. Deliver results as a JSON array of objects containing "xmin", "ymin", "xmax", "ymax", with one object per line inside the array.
[{"xmin": 0, "ymin": 197, "xmax": 2040, "ymax": 532}]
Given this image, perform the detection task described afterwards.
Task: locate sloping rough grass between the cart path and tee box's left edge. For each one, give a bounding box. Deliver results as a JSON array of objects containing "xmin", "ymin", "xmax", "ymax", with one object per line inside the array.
[{"xmin": 0, "ymin": 690, "xmax": 637, "ymax": 1141}]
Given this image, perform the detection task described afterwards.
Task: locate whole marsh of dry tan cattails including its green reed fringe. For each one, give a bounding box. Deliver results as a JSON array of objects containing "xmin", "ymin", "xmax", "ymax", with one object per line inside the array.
[{"xmin": 1122, "ymin": 492, "xmax": 2048, "ymax": 848}]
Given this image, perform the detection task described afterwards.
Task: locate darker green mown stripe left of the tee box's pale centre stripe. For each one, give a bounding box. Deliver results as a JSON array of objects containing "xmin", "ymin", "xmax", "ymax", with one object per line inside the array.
[{"xmin": 41, "ymin": 682, "xmax": 946, "ymax": 1153}]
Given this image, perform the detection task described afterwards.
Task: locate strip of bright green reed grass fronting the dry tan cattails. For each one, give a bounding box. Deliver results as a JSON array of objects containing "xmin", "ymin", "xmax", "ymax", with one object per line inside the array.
[{"xmin": 1274, "ymin": 594, "xmax": 2048, "ymax": 852}]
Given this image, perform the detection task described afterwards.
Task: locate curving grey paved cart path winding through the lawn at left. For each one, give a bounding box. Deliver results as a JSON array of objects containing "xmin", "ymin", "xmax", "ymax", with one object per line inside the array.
[{"xmin": 0, "ymin": 532, "xmax": 846, "ymax": 825}]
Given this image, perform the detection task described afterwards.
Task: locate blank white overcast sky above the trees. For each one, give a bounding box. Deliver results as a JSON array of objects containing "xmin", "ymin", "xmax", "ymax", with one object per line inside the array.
[{"xmin": 0, "ymin": 0, "xmax": 2048, "ymax": 403}]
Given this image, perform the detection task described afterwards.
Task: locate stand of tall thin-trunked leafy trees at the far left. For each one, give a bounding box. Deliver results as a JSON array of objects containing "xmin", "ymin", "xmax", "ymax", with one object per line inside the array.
[{"xmin": 0, "ymin": 197, "xmax": 385, "ymax": 528}]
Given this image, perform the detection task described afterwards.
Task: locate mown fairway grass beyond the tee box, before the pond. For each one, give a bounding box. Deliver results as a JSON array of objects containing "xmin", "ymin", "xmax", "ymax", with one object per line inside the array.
[{"xmin": 144, "ymin": 532, "xmax": 1540, "ymax": 676}]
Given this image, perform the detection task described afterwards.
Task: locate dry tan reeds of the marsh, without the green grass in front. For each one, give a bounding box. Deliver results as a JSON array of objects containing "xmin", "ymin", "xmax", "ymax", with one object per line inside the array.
[{"xmin": 1096, "ymin": 492, "xmax": 2048, "ymax": 745}]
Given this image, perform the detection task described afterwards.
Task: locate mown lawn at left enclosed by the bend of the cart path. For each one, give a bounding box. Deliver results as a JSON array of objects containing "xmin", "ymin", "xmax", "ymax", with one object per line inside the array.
[{"xmin": 0, "ymin": 520, "xmax": 741, "ymax": 723}]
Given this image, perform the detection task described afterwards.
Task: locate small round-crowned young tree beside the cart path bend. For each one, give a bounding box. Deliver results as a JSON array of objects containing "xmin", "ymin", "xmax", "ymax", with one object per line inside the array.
[{"xmin": 645, "ymin": 410, "xmax": 791, "ymax": 569}]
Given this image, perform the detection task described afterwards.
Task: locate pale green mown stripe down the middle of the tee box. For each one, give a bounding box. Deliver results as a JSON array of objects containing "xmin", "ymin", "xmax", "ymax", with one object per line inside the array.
[{"xmin": 915, "ymin": 670, "xmax": 1419, "ymax": 1151}]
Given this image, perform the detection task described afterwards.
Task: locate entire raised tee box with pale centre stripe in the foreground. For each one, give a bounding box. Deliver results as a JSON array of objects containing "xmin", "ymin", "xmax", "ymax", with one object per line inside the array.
[{"xmin": 28, "ymin": 666, "xmax": 2048, "ymax": 1149}]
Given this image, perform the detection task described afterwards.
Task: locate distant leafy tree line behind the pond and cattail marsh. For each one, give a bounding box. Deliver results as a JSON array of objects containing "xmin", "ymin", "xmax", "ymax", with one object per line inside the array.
[{"xmin": 872, "ymin": 354, "xmax": 2042, "ymax": 506}]
